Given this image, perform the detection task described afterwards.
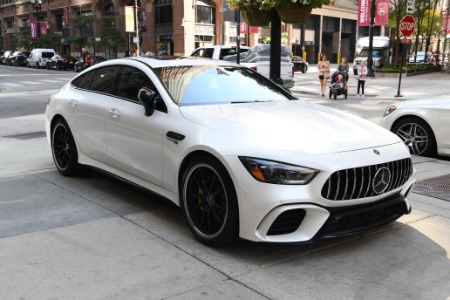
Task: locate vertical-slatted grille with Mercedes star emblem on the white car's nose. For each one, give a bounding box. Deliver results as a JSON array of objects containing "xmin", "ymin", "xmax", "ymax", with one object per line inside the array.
[{"xmin": 322, "ymin": 158, "xmax": 413, "ymax": 201}]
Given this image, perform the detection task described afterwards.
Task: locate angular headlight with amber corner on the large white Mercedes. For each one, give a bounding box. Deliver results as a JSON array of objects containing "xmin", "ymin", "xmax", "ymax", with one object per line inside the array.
[{"xmin": 239, "ymin": 156, "xmax": 319, "ymax": 184}]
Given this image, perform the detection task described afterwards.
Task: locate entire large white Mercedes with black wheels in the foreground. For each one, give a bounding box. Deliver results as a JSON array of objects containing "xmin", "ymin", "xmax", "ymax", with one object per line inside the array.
[{"xmin": 45, "ymin": 57, "xmax": 414, "ymax": 245}]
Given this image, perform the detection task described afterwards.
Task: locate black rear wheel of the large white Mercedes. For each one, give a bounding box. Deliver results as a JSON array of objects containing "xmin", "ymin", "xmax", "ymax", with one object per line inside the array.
[{"xmin": 51, "ymin": 119, "xmax": 81, "ymax": 176}]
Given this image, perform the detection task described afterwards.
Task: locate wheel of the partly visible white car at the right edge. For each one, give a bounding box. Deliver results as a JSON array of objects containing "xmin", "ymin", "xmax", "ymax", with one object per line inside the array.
[{"xmin": 392, "ymin": 117, "xmax": 437, "ymax": 157}]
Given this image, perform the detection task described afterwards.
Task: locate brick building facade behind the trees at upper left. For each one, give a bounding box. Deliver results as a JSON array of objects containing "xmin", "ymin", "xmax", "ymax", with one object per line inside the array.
[{"xmin": 0, "ymin": 0, "xmax": 224, "ymax": 56}]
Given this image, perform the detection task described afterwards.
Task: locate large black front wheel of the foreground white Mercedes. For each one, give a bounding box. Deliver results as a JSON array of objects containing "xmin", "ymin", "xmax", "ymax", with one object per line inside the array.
[{"xmin": 180, "ymin": 157, "xmax": 239, "ymax": 246}]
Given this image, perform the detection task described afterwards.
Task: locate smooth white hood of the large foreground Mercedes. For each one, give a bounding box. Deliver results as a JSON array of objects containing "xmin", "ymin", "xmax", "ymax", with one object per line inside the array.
[{"xmin": 181, "ymin": 100, "xmax": 400, "ymax": 154}]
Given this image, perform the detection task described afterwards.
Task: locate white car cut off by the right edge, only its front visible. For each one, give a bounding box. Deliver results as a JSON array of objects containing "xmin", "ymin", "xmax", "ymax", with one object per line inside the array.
[{"xmin": 380, "ymin": 96, "xmax": 450, "ymax": 157}]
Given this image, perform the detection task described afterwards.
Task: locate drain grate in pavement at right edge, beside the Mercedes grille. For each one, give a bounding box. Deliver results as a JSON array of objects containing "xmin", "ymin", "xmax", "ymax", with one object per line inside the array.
[{"xmin": 412, "ymin": 174, "xmax": 450, "ymax": 201}]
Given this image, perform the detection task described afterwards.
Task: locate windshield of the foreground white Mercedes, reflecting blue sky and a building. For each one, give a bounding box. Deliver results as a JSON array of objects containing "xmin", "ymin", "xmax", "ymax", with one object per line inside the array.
[{"xmin": 155, "ymin": 65, "xmax": 288, "ymax": 106}]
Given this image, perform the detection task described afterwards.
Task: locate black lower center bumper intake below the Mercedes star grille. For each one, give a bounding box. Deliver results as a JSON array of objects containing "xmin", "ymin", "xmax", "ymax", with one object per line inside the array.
[{"xmin": 314, "ymin": 197, "xmax": 409, "ymax": 239}]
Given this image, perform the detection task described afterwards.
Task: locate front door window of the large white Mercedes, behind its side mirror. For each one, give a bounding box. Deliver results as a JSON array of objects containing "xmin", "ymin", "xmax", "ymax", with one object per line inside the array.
[{"xmin": 114, "ymin": 67, "xmax": 157, "ymax": 102}]
